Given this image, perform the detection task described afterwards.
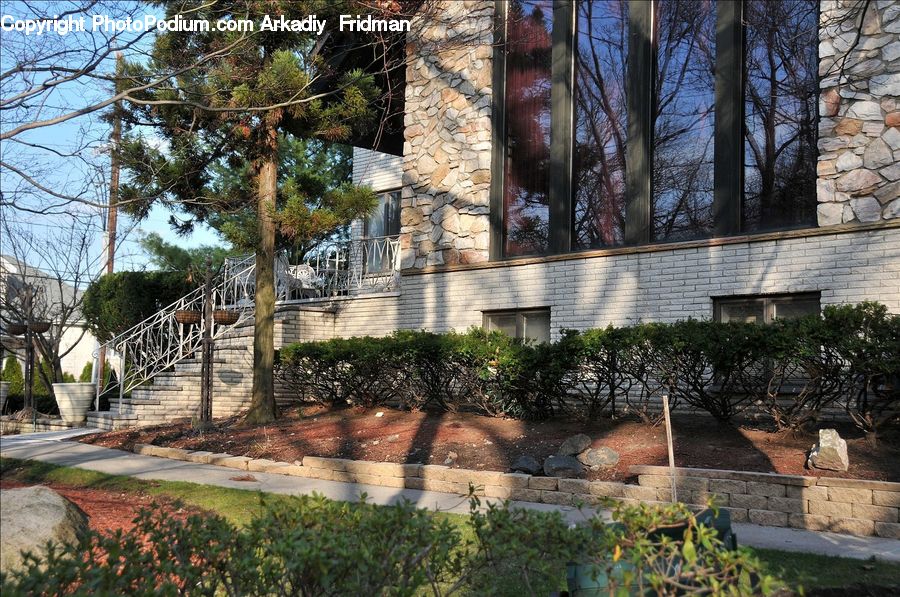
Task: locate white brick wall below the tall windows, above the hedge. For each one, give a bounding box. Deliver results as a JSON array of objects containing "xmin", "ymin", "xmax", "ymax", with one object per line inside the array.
[{"xmin": 284, "ymin": 228, "xmax": 900, "ymax": 341}]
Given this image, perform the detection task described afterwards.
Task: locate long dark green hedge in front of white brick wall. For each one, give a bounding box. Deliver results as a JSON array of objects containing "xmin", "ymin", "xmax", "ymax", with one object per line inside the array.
[{"xmin": 278, "ymin": 303, "xmax": 900, "ymax": 432}]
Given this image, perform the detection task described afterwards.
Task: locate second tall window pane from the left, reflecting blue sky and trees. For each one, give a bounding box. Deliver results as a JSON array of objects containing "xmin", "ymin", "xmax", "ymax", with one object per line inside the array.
[{"xmin": 572, "ymin": 0, "xmax": 628, "ymax": 250}]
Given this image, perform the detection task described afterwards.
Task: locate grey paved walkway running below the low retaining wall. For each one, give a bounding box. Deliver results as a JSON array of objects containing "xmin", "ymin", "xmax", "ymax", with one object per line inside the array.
[{"xmin": 0, "ymin": 429, "xmax": 900, "ymax": 562}]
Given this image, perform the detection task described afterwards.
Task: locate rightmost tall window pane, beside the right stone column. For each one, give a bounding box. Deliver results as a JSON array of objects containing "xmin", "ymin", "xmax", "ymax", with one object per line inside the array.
[{"xmin": 741, "ymin": 0, "xmax": 819, "ymax": 231}]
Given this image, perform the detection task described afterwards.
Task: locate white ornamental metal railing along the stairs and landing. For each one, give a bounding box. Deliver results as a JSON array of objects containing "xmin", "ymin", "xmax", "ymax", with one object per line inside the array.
[{"xmin": 97, "ymin": 237, "xmax": 400, "ymax": 408}]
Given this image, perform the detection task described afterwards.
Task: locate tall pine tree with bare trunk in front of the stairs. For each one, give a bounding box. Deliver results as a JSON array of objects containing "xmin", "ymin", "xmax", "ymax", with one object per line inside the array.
[{"xmin": 119, "ymin": 0, "xmax": 377, "ymax": 423}]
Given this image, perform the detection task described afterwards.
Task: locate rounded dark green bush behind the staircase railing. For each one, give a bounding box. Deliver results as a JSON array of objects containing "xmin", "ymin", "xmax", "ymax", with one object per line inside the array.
[{"xmin": 82, "ymin": 272, "xmax": 193, "ymax": 342}]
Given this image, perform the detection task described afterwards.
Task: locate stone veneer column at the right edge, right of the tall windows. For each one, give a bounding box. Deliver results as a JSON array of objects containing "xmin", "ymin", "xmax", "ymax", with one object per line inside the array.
[{"xmin": 817, "ymin": 0, "xmax": 900, "ymax": 226}]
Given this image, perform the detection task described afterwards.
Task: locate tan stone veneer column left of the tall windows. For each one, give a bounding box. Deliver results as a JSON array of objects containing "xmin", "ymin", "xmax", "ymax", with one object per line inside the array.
[{"xmin": 400, "ymin": 0, "xmax": 494, "ymax": 269}]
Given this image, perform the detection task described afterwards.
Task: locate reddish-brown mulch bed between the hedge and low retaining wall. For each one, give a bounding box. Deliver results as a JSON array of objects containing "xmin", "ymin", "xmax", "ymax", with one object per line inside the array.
[{"xmin": 80, "ymin": 407, "xmax": 900, "ymax": 481}]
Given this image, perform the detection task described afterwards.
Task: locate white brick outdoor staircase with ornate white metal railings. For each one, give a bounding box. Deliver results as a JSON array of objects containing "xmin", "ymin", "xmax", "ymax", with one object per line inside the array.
[{"xmin": 87, "ymin": 237, "xmax": 400, "ymax": 430}]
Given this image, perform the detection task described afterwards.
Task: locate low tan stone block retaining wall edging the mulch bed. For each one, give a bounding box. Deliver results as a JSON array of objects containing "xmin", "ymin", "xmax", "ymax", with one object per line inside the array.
[{"xmin": 134, "ymin": 444, "xmax": 900, "ymax": 539}]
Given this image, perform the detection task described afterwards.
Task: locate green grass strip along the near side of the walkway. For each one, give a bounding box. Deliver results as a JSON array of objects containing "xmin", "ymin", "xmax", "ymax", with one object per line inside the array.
[{"xmin": 0, "ymin": 458, "xmax": 900, "ymax": 589}]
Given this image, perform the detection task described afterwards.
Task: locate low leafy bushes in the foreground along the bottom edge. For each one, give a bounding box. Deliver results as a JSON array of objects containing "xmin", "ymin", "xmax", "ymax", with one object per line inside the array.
[{"xmin": 0, "ymin": 496, "xmax": 772, "ymax": 596}]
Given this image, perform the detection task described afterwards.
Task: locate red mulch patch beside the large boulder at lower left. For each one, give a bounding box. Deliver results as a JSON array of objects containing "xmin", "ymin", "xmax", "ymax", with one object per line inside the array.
[{"xmin": 0, "ymin": 479, "xmax": 200, "ymax": 535}]
